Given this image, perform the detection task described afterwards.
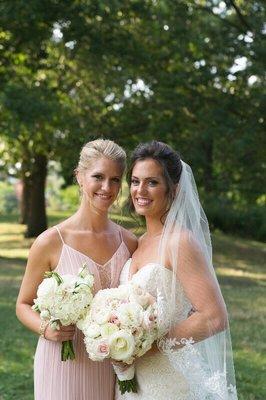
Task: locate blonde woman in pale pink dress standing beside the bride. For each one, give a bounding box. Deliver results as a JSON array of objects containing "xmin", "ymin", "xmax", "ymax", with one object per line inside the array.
[{"xmin": 16, "ymin": 139, "xmax": 137, "ymax": 400}]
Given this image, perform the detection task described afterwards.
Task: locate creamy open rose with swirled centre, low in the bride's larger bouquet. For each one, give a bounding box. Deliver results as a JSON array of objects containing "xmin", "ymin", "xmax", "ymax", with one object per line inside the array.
[{"xmin": 108, "ymin": 330, "xmax": 135, "ymax": 361}]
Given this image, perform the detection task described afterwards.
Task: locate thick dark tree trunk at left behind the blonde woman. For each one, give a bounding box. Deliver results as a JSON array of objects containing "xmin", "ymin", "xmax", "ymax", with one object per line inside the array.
[{"xmin": 25, "ymin": 155, "xmax": 47, "ymax": 237}]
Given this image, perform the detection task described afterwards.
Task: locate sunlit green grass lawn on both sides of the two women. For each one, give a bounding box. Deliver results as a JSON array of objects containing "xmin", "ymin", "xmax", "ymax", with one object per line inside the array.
[{"xmin": 0, "ymin": 213, "xmax": 266, "ymax": 400}]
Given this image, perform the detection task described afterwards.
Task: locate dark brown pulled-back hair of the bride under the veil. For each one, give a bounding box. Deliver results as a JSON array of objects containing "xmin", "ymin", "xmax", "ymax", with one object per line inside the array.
[{"xmin": 127, "ymin": 140, "xmax": 182, "ymax": 219}]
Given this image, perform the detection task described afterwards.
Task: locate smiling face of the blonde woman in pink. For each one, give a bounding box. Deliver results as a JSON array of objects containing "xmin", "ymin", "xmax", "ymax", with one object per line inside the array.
[{"xmin": 77, "ymin": 157, "xmax": 122, "ymax": 211}]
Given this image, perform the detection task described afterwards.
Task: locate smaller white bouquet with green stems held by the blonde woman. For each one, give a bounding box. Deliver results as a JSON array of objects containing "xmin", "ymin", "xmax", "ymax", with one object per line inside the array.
[{"xmin": 32, "ymin": 264, "xmax": 94, "ymax": 361}]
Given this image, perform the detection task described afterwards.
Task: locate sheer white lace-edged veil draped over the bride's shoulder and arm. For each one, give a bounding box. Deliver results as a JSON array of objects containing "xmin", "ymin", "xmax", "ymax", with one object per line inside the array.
[{"xmin": 157, "ymin": 161, "xmax": 237, "ymax": 400}]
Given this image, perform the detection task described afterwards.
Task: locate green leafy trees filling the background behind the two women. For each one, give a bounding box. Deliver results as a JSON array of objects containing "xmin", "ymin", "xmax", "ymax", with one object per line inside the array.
[{"xmin": 0, "ymin": 0, "xmax": 266, "ymax": 240}]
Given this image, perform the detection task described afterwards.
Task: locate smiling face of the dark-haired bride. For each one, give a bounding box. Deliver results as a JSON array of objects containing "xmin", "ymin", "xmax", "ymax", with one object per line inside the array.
[{"xmin": 130, "ymin": 159, "xmax": 167, "ymax": 219}]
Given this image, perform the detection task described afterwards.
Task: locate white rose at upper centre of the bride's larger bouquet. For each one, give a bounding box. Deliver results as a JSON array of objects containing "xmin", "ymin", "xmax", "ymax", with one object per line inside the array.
[{"xmin": 116, "ymin": 303, "xmax": 143, "ymax": 328}]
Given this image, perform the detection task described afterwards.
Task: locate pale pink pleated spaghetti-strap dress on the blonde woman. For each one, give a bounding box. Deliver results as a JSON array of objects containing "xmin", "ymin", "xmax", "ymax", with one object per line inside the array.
[{"xmin": 34, "ymin": 227, "xmax": 130, "ymax": 400}]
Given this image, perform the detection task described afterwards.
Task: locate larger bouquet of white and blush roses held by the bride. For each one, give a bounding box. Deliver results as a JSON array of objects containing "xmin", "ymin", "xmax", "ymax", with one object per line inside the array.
[{"xmin": 77, "ymin": 283, "xmax": 158, "ymax": 394}]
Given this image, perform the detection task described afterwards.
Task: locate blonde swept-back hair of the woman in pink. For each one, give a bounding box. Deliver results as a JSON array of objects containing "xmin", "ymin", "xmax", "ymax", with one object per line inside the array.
[{"xmin": 75, "ymin": 139, "xmax": 126, "ymax": 175}]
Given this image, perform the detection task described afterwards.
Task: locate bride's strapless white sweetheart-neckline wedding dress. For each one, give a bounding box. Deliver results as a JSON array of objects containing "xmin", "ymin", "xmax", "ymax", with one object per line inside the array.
[{"xmin": 115, "ymin": 259, "xmax": 190, "ymax": 400}]
